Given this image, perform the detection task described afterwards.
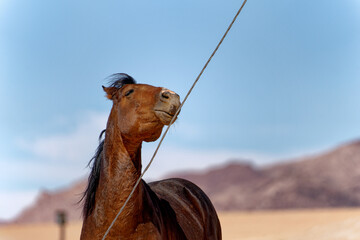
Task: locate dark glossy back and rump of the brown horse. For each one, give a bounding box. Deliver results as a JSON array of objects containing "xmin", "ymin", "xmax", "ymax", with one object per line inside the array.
[{"xmin": 149, "ymin": 178, "xmax": 221, "ymax": 240}]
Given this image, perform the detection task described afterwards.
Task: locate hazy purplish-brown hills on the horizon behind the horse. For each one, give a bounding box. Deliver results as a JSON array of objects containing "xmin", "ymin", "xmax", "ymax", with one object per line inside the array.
[{"xmin": 15, "ymin": 141, "xmax": 360, "ymax": 223}]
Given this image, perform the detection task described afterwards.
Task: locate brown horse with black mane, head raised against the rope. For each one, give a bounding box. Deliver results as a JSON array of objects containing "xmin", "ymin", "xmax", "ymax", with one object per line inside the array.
[{"xmin": 81, "ymin": 74, "xmax": 221, "ymax": 240}]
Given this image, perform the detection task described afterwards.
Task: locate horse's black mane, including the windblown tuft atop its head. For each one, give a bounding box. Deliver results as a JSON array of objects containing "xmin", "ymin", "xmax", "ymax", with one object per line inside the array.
[{"xmin": 80, "ymin": 73, "xmax": 136, "ymax": 219}]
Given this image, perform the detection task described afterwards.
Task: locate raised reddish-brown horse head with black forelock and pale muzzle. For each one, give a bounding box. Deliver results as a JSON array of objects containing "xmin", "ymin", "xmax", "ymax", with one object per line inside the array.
[{"xmin": 103, "ymin": 74, "xmax": 180, "ymax": 142}]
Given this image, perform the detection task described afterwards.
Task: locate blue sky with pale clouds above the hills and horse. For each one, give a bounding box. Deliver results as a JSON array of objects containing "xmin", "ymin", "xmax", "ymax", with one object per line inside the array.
[{"xmin": 0, "ymin": 0, "xmax": 360, "ymax": 218}]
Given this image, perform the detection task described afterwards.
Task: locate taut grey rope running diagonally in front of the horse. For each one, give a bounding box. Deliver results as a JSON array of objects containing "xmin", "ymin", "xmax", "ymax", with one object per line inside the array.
[{"xmin": 102, "ymin": 0, "xmax": 247, "ymax": 240}]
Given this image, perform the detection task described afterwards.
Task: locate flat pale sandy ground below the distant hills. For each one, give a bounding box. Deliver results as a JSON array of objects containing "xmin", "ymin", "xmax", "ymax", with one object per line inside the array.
[{"xmin": 0, "ymin": 208, "xmax": 360, "ymax": 240}]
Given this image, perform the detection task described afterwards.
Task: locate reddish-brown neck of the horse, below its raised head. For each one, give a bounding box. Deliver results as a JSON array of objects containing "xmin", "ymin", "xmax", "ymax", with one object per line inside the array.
[{"xmin": 94, "ymin": 108, "xmax": 143, "ymax": 231}]
